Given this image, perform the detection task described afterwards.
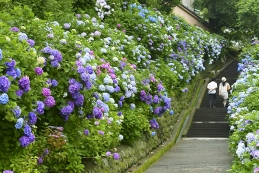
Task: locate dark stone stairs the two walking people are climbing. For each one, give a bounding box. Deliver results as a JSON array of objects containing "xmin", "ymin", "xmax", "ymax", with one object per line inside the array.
[{"xmin": 186, "ymin": 61, "xmax": 238, "ymax": 138}]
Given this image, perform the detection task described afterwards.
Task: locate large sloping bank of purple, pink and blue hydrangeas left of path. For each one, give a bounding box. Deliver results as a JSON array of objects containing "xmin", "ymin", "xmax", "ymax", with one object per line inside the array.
[{"xmin": 0, "ymin": 0, "xmax": 223, "ymax": 172}]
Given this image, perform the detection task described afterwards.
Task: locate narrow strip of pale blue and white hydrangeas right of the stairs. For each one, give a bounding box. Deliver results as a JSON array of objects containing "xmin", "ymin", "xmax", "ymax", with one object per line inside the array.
[{"xmin": 228, "ymin": 44, "xmax": 259, "ymax": 172}]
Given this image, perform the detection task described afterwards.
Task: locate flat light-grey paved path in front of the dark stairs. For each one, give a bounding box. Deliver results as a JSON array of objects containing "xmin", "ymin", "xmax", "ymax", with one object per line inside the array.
[{"xmin": 145, "ymin": 138, "xmax": 232, "ymax": 173}]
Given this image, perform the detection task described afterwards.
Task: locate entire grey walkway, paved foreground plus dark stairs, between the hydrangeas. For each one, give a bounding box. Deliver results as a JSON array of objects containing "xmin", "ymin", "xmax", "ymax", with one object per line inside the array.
[{"xmin": 144, "ymin": 61, "xmax": 238, "ymax": 173}]
